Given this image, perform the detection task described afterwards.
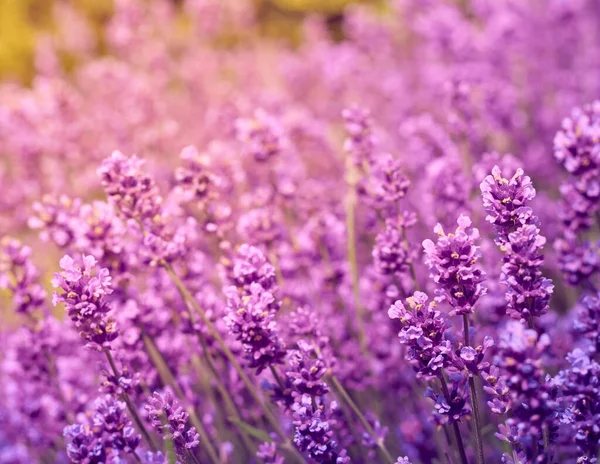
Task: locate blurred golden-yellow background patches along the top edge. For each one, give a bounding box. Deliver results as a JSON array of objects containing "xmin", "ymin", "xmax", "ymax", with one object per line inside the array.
[{"xmin": 0, "ymin": 0, "xmax": 378, "ymax": 82}]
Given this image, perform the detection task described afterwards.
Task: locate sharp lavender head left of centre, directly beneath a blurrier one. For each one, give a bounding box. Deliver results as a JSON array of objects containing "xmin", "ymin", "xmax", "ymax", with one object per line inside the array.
[{"xmin": 225, "ymin": 283, "xmax": 285, "ymax": 373}]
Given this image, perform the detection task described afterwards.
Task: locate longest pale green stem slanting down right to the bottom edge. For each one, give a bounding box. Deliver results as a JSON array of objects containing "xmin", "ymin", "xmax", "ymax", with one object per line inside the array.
[{"xmin": 162, "ymin": 262, "xmax": 304, "ymax": 462}]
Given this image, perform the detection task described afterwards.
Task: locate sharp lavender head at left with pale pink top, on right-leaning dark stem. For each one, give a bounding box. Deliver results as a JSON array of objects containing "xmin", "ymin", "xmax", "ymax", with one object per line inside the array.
[{"xmin": 52, "ymin": 255, "xmax": 118, "ymax": 351}]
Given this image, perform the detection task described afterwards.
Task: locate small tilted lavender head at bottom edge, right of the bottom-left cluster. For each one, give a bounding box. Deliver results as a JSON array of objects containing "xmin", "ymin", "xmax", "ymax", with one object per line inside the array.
[{"xmin": 144, "ymin": 391, "xmax": 200, "ymax": 459}]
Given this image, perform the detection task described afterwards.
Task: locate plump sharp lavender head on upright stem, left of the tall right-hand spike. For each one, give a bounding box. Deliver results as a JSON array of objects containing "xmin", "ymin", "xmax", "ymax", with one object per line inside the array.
[{"xmin": 423, "ymin": 216, "xmax": 486, "ymax": 314}]
